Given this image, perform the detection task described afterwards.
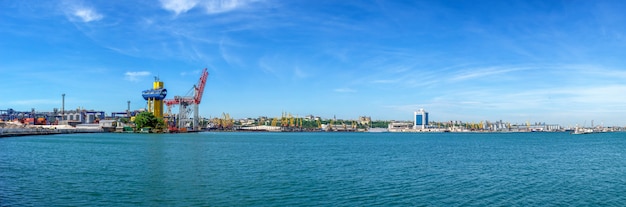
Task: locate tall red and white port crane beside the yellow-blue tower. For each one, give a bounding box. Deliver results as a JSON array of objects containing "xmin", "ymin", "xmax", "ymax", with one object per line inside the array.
[{"xmin": 163, "ymin": 68, "xmax": 209, "ymax": 131}]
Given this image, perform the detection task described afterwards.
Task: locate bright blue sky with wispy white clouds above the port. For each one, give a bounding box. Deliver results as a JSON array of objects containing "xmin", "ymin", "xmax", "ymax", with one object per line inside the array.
[{"xmin": 0, "ymin": 0, "xmax": 626, "ymax": 126}]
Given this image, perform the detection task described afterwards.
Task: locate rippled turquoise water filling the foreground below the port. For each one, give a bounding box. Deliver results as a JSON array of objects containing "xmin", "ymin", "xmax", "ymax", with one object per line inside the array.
[{"xmin": 0, "ymin": 133, "xmax": 626, "ymax": 206}]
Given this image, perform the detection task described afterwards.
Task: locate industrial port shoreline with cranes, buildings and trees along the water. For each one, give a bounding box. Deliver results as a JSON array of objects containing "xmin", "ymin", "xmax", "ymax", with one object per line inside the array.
[{"xmin": 0, "ymin": 68, "xmax": 624, "ymax": 137}]
